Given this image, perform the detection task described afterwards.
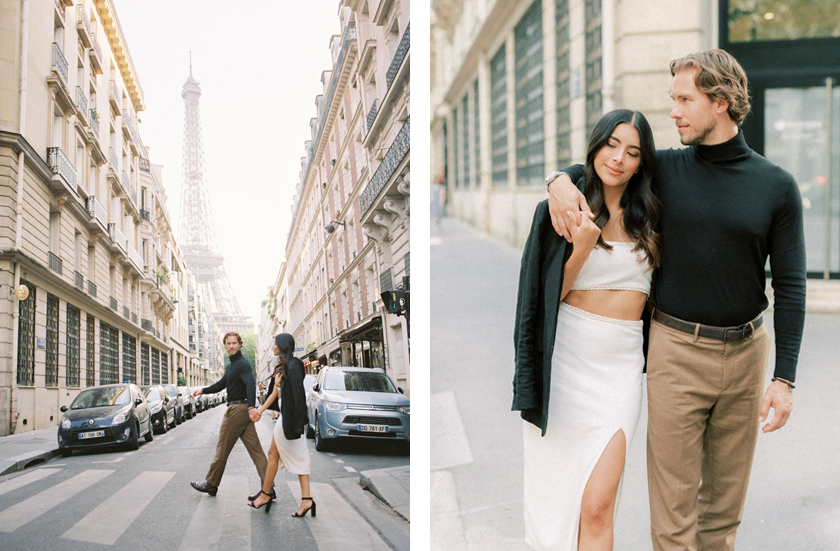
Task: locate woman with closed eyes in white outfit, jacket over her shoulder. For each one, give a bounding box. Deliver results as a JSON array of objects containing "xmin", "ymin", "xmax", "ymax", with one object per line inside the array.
[{"xmin": 513, "ymin": 110, "xmax": 661, "ymax": 551}]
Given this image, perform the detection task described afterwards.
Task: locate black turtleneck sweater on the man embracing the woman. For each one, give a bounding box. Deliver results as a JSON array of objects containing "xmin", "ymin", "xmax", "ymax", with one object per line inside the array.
[{"xmin": 563, "ymin": 130, "xmax": 805, "ymax": 381}]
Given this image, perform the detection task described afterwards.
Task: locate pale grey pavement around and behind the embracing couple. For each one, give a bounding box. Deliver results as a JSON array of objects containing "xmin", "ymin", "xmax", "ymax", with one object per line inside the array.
[{"xmin": 430, "ymin": 219, "xmax": 840, "ymax": 551}]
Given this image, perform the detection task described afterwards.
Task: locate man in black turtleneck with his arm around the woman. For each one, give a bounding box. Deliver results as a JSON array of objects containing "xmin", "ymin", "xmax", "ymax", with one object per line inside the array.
[{"xmin": 547, "ymin": 50, "xmax": 805, "ymax": 551}]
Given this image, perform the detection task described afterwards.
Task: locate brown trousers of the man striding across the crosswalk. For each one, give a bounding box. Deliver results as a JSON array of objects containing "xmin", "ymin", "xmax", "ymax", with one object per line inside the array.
[{"xmin": 205, "ymin": 404, "xmax": 268, "ymax": 488}]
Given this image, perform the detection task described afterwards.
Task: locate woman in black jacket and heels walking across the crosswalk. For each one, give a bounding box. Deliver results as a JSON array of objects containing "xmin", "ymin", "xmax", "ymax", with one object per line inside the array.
[{"xmin": 248, "ymin": 333, "xmax": 316, "ymax": 517}]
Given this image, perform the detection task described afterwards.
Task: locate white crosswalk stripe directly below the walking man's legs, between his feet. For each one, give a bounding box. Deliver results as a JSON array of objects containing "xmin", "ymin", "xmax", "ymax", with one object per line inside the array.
[{"xmin": 180, "ymin": 476, "xmax": 251, "ymax": 551}]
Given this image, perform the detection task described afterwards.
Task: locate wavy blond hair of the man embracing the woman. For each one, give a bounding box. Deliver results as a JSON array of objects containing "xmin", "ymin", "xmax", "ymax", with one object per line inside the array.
[{"xmin": 671, "ymin": 49, "xmax": 750, "ymax": 126}]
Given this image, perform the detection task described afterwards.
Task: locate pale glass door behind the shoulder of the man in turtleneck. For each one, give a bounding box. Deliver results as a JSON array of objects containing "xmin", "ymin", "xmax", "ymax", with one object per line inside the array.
[{"xmin": 764, "ymin": 78, "xmax": 840, "ymax": 279}]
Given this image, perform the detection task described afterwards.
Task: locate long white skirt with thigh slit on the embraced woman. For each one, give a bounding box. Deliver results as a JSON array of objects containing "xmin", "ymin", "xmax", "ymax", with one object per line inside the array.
[{"xmin": 523, "ymin": 303, "xmax": 644, "ymax": 551}]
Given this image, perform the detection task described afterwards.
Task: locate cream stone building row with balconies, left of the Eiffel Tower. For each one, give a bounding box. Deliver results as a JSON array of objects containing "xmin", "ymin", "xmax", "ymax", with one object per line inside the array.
[{"xmin": 0, "ymin": 0, "xmax": 220, "ymax": 435}]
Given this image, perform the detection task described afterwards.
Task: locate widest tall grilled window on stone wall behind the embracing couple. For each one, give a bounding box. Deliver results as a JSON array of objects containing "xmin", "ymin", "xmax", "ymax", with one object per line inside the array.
[{"xmin": 514, "ymin": 0, "xmax": 545, "ymax": 186}]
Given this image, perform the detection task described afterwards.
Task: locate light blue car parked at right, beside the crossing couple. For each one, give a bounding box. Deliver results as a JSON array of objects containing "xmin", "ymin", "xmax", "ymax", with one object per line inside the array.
[{"xmin": 307, "ymin": 366, "xmax": 411, "ymax": 451}]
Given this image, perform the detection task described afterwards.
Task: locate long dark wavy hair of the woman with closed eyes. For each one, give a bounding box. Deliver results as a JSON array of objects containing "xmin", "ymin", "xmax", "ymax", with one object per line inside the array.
[{"xmin": 584, "ymin": 109, "xmax": 662, "ymax": 268}]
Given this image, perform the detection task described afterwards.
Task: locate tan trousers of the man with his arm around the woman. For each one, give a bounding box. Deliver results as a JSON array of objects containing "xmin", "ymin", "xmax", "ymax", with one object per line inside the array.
[{"xmin": 647, "ymin": 321, "xmax": 770, "ymax": 551}]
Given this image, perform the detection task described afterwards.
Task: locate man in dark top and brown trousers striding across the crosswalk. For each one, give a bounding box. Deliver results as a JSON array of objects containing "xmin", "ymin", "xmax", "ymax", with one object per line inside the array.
[{"xmin": 190, "ymin": 331, "xmax": 268, "ymax": 496}]
